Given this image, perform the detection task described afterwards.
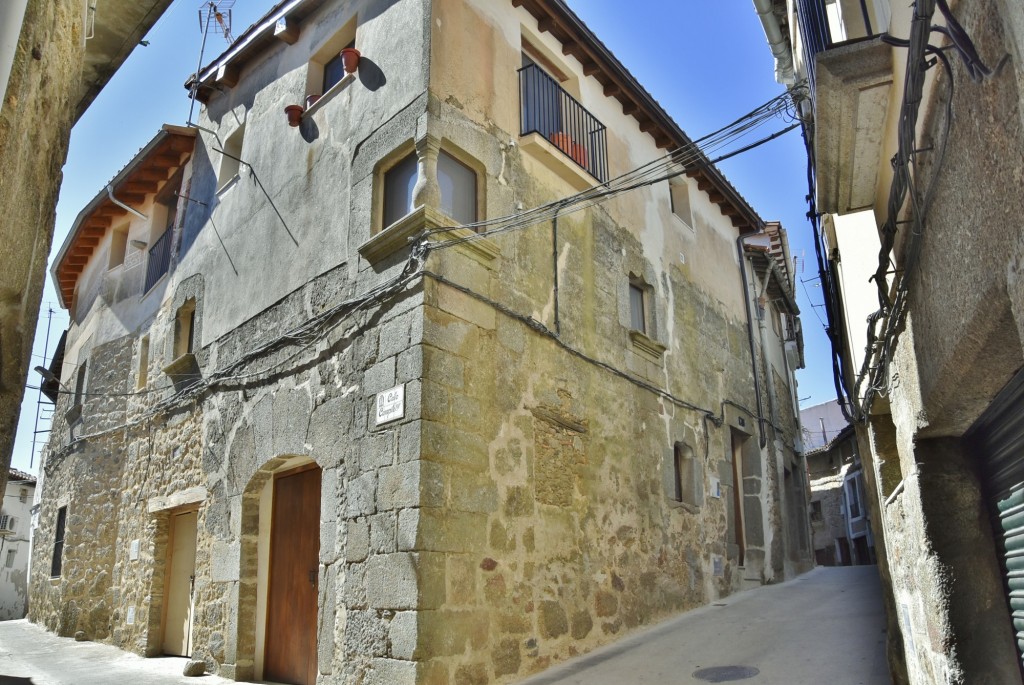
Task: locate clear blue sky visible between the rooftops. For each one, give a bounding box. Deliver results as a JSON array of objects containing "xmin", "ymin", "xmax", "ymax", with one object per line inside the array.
[{"xmin": 12, "ymin": 0, "xmax": 835, "ymax": 471}]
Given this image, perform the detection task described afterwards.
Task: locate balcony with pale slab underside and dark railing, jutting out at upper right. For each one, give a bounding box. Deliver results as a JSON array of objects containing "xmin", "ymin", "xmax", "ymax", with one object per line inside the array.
[{"xmin": 797, "ymin": 0, "xmax": 893, "ymax": 214}]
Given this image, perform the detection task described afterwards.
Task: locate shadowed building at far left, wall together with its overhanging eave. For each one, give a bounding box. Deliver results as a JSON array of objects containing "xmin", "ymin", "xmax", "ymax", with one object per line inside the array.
[{"xmin": 0, "ymin": 0, "xmax": 171, "ymax": 501}]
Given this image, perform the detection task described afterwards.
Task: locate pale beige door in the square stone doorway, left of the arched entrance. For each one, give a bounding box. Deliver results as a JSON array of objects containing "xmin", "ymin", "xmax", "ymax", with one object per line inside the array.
[{"xmin": 163, "ymin": 511, "xmax": 199, "ymax": 656}]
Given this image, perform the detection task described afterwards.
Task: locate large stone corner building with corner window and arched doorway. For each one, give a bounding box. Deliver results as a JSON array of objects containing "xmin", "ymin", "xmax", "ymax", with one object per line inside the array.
[{"xmin": 30, "ymin": 0, "xmax": 811, "ymax": 684}]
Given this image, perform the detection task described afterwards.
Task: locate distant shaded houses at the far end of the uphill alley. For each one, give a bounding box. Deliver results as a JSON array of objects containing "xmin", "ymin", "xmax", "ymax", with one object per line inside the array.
[{"xmin": 800, "ymin": 400, "xmax": 874, "ymax": 566}]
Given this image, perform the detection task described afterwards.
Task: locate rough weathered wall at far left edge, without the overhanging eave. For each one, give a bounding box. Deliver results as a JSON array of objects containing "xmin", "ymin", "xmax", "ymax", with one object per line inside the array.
[{"xmin": 0, "ymin": 0, "xmax": 83, "ymax": 497}]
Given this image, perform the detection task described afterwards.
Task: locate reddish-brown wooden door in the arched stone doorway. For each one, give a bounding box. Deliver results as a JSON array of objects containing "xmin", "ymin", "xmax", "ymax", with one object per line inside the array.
[{"xmin": 263, "ymin": 467, "xmax": 321, "ymax": 685}]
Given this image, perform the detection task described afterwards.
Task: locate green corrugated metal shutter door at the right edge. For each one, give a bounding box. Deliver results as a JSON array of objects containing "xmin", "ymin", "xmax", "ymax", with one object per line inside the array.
[{"xmin": 970, "ymin": 371, "xmax": 1024, "ymax": 677}]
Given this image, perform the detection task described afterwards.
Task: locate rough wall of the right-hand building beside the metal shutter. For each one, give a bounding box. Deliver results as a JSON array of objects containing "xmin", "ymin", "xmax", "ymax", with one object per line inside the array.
[{"xmin": 859, "ymin": 0, "xmax": 1024, "ymax": 683}]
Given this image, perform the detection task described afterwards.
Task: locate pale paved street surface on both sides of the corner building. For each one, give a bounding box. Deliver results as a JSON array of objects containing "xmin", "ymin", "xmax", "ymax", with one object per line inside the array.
[{"xmin": 0, "ymin": 566, "xmax": 889, "ymax": 685}]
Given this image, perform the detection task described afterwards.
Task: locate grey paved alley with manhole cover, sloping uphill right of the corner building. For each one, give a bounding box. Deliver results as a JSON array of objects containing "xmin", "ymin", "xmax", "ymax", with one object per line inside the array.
[{"xmin": 522, "ymin": 566, "xmax": 891, "ymax": 685}]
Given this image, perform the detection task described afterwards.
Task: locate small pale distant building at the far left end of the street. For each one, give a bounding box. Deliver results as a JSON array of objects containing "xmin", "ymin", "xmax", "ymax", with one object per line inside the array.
[{"xmin": 0, "ymin": 469, "xmax": 36, "ymax": 620}]
